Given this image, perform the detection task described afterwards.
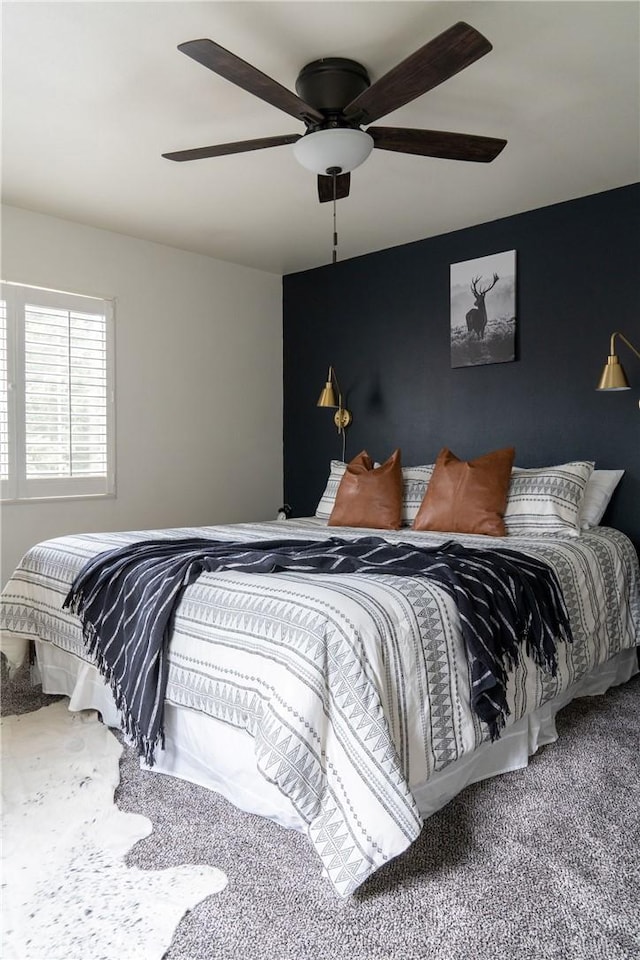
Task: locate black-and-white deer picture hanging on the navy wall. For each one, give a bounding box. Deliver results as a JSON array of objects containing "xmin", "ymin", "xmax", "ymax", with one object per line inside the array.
[{"xmin": 451, "ymin": 250, "xmax": 516, "ymax": 367}]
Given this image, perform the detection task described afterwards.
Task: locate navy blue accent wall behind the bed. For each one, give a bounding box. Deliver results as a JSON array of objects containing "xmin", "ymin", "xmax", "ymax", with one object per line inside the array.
[{"xmin": 283, "ymin": 184, "xmax": 640, "ymax": 548}]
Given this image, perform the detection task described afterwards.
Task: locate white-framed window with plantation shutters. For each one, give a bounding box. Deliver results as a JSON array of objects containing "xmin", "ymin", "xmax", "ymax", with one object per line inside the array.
[{"xmin": 0, "ymin": 283, "xmax": 115, "ymax": 500}]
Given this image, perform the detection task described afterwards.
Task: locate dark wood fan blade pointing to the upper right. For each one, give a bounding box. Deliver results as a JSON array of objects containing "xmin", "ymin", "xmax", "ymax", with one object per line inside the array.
[{"xmin": 344, "ymin": 21, "xmax": 492, "ymax": 123}]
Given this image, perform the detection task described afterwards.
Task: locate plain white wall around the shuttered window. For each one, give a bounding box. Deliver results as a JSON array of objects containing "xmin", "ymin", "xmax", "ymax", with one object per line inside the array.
[{"xmin": 0, "ymin": 206, "xmax": 282, "ymax": 583}]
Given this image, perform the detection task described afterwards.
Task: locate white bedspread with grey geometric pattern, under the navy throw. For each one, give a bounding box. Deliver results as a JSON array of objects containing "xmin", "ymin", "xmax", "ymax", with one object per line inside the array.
[{"xmin": 0, "ymin": 518, "xmax": 640, "ymax": 896}]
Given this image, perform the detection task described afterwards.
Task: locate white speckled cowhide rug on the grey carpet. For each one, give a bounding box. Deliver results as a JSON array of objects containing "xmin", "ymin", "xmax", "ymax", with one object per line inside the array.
[{"xmin": 1, "ymin": 700, "xmax": 227, "ymax": 960}]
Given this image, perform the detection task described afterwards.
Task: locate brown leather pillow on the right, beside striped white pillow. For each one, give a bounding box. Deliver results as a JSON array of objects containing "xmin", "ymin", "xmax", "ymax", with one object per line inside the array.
[{"xmin": 413, "ymin": 447, "xmax": 515, "ymax": 537}]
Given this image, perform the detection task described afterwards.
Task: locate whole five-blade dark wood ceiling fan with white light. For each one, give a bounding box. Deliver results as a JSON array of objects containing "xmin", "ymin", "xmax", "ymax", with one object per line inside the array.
[{"xmin": 163, "ymin": 22, "xmax": 507, "ymax": 203}]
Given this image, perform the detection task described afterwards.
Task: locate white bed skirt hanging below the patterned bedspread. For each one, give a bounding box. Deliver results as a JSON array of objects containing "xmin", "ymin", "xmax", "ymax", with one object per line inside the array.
[{"xmin": 32, "ymin": 641, "xmax": 638, "ymax": 832}]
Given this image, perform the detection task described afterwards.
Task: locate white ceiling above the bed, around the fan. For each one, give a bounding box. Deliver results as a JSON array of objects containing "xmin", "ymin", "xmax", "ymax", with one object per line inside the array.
[{"xmin": 2, "ymin": 0, "xmax": 640, "ymax": 274}]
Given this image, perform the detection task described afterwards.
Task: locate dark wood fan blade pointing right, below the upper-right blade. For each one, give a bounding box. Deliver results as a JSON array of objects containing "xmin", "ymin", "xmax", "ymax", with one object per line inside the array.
[{"xmin": 367, "ymin": 127, "xmax": 507, "ymax": 163}]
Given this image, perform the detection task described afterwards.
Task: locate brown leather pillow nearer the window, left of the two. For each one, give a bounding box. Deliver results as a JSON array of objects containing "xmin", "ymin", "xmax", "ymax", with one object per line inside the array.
[{"xmin": 328, "ymin": 450, "xmax": 402, "ymax": 530}]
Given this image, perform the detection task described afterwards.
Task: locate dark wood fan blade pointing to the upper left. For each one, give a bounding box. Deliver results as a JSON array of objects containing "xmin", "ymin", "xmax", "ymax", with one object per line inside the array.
[{"xmin": 178, "ymin": 39, "xmax": 324, "ymax": 122}]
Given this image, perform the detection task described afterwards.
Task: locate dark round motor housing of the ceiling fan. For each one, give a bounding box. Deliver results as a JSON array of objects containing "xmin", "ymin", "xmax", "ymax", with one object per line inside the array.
[{"xmin": 296, "ymin": 57, "xmax": 370, "ymax": 126}]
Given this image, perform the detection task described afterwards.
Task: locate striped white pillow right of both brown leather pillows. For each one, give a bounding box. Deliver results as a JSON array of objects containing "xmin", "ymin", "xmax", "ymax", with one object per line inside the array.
[{"xmin": 504, "ymin": 460, "xmax": 594, "ymax": 537}]
